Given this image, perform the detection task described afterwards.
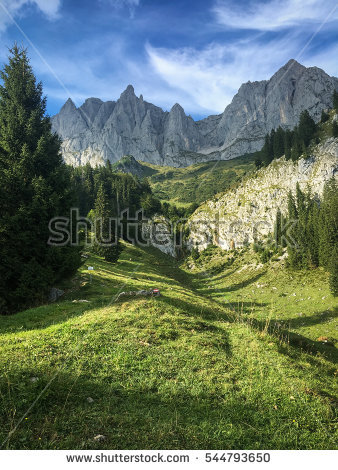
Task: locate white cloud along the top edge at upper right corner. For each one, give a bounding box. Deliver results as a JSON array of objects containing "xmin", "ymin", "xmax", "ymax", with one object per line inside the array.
[{"xmin": 212, "ymin": 0, "xmax": 338, "ymax": 31}]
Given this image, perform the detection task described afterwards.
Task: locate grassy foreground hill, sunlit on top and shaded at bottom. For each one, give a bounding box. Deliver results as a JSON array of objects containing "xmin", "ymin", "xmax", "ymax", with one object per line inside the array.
[{"xmin": 0, "ymin": 242, "xmax": 337, "ymax": 449}]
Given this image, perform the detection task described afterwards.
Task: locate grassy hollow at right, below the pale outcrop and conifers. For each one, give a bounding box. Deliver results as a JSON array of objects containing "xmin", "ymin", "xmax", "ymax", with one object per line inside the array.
[{"xmin": 185, "ymin": 247, "xmax": 338, "ymax": 344}]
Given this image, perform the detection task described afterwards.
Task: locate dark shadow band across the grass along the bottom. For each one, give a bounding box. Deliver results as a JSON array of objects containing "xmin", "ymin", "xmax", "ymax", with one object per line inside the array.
[{"xmin": 0, "ymin": 371, "xmax": 333, "ymax": 450}]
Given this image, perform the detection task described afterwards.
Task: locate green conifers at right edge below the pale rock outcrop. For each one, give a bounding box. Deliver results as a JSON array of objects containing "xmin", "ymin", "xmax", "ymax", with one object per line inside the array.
[{"xmin": 275, "ymin": 178, "xmax": 338, "ymax": 295}]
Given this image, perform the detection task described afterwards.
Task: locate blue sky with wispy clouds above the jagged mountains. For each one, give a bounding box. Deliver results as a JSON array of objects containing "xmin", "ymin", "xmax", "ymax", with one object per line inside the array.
[{"xmin": 0, "ymin": 0, "xmax": 338, "ymax": 119}]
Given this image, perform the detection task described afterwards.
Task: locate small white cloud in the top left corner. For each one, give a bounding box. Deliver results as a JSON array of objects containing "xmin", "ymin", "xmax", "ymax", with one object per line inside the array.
[{"xmin": 0, "ymin": 0, "xmax": 61, "ymax": 31}]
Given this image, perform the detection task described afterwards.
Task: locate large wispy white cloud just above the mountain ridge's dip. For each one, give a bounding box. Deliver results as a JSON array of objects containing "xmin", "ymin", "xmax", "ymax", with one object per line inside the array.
[{"xmin": 146, "ymin": 35, "xmax": 301, "ymax": 112}]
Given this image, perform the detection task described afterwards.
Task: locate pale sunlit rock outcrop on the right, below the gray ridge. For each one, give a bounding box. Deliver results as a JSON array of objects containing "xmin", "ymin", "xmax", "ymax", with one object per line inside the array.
[{"xmin": 188, "ymin": 138, "xmax": 338, "ymax": 251}]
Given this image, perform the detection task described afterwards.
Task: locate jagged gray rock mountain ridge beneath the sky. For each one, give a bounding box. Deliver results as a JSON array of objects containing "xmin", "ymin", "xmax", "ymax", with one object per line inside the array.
[{"xmin": 52, "ymin": 60, "xmax": 338, "ymax": 167}]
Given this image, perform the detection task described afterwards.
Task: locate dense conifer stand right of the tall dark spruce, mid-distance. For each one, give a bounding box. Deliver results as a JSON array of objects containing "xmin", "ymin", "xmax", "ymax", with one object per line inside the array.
[{"xmin": 71, "ymin": 161, "xmax": 162, "ymax": 262}]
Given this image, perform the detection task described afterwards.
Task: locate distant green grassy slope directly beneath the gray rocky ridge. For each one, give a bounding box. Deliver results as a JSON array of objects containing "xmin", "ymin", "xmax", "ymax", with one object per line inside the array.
[{"xmin": 139, "ymin": 155, "xmax": 254, "ymax": 207}]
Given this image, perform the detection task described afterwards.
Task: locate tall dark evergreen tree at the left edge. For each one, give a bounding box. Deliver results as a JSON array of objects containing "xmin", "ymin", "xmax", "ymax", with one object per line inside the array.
[{"xmin": 0, "ymin": 45, "xmax": 80, "ymax": 313}]
